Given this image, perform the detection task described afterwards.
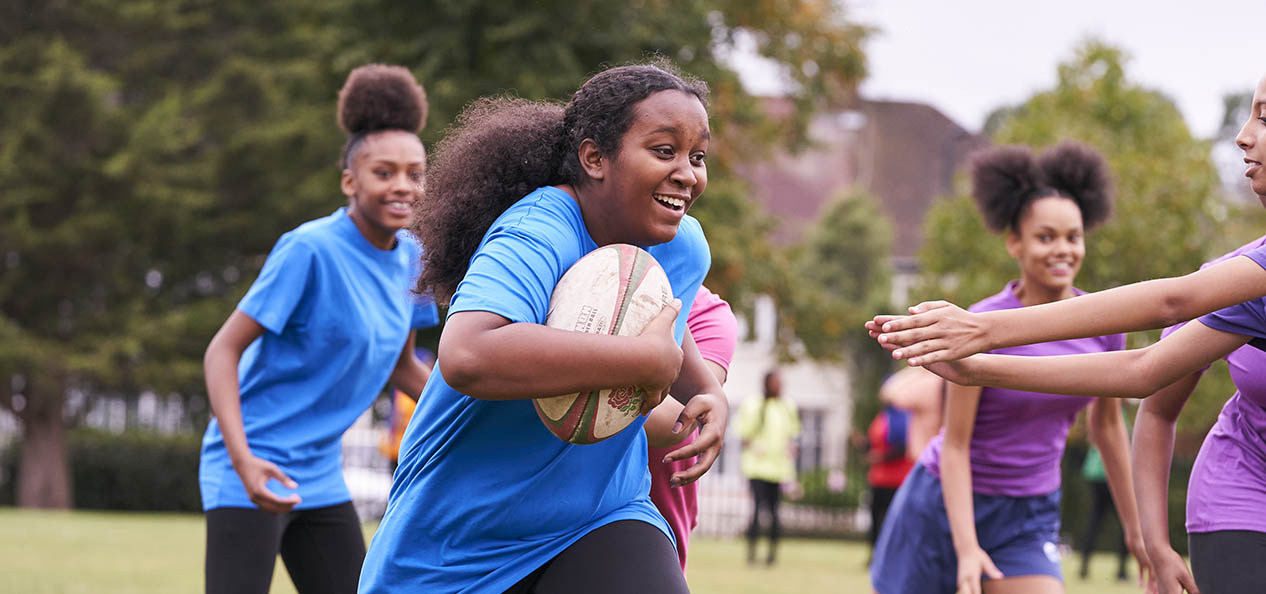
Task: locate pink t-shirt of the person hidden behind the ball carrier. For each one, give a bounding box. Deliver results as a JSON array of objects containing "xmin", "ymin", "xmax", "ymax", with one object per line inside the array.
[{"xmin": 647, "ymin": 286, "xmax": 738, "ymax": 571}]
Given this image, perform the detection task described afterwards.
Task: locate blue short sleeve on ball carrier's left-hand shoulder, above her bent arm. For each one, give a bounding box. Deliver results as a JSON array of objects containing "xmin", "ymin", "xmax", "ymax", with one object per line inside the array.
[{"xmin": 448, "ymin": 227, "xmax": 564, "ymax": 324}]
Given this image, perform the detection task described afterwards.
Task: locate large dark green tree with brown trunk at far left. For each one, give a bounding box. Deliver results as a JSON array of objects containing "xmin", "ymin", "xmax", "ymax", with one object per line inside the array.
[{"xmin": 0, "ymin": 1, "xmax": 341, "ymax": 508}]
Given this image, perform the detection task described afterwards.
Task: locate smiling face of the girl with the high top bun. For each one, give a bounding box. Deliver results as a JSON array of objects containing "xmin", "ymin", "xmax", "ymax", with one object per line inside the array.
[{"xmin": 342, "ymin": 130, "xmax": 427, "ymax": 250}]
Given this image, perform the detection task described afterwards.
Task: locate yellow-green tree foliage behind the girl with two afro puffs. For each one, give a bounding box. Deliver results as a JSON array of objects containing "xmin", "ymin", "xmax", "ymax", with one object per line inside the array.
[{"xmin": 914, "ymin": 41, "xmax": 1245, "ymax": 438}]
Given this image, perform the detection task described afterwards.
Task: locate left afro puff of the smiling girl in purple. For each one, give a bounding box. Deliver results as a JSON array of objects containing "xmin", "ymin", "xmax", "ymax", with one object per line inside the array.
[{"xmin": 971, "ymin": 146, "xmax": 1042, "ymax": 233}]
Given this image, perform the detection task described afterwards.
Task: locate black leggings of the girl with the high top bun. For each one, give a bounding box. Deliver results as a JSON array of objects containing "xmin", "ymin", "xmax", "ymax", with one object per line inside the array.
[{"xmin": 206, "ymin": 502, "xmax": 367, "ymax": 594}]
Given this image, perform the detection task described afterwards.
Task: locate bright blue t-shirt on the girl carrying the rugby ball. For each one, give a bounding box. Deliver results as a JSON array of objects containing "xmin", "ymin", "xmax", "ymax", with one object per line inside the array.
[{"xmin": 360, "ymin": 187, "xmax": 711, "ymax": 594}]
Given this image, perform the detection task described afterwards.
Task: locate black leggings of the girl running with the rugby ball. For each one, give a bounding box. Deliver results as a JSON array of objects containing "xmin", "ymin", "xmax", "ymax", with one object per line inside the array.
[{"xmin": 505, "ymin": 519, "xmax": 690, "ymax": 594}]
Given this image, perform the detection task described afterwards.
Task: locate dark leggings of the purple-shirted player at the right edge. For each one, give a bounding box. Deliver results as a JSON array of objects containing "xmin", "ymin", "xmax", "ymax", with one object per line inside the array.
[{"xmin": 1188, "ymin": 531, "xmax": 1266, "ymax": 594}]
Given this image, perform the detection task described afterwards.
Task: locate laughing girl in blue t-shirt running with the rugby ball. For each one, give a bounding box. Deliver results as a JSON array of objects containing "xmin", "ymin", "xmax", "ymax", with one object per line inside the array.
[{"xmin": 361, "ymin": 65, "xmax": 728, "ymax": 594}]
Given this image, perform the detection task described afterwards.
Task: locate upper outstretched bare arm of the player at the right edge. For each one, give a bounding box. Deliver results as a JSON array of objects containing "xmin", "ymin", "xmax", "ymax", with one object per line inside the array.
[{"xmin": 866, "ymin": 256, "xmax": 1266, "ymax": 365}]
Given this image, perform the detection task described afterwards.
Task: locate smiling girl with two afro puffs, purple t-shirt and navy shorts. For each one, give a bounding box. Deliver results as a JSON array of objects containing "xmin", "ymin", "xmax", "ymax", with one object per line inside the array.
[{"xmin": 871, "ymin": 142, "xmax": 1147, "ymax": 594}]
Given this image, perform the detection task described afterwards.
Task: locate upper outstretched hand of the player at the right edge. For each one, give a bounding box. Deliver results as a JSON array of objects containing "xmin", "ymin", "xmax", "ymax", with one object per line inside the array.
[{"xmin": 866, "ymin": 301, "xmax": 990, "ymax": 365}]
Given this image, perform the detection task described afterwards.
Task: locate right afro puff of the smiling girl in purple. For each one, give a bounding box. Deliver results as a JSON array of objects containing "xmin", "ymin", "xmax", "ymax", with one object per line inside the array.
[{"xmin": 1038, "ymin": 141, "xmax": 1113, "ymax": 229}]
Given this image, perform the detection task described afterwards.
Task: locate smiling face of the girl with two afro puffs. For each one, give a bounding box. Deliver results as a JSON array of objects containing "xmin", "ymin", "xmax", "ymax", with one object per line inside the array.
[{"xmin": 1006, "ymin": 196, "xmax": 1086, "ymax": 305}]
